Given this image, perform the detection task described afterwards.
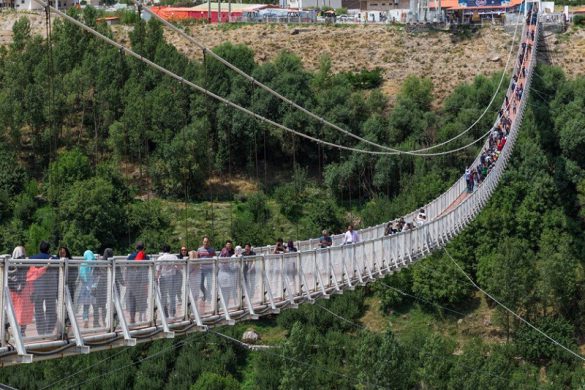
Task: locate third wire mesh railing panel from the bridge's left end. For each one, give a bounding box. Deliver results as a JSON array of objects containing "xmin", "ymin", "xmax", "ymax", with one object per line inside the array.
[{"xmin": 116, "ymin": 260, "xmax": 153, "ymax": 328}]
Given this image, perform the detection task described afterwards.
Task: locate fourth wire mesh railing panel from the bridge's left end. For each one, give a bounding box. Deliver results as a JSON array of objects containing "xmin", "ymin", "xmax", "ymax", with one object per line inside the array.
[{"xmin": 156, "ymin": 260, "xmax": 186, "ymax": 324}]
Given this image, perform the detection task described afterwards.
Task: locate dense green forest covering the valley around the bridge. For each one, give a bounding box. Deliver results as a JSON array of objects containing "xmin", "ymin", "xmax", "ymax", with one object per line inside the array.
[{"xmin": 0, "ymin": 8, "xmax": 585, "ymax": 389}]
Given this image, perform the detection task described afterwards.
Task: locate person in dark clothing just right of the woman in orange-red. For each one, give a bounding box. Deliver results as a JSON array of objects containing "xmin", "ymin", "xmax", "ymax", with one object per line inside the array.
[{"xmin": 30, "ymin": 241, "xmax": 59, "ymax": 335}]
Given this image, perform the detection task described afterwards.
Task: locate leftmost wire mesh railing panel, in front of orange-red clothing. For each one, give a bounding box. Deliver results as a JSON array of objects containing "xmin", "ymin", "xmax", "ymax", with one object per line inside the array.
[{"xmin": 7, "ymin": 261, "xmax": 60, "ymax": 341}]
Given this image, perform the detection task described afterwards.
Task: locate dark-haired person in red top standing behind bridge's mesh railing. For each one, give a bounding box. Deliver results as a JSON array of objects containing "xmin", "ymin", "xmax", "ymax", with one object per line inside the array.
[{"xmin": 126, "ymin": 241, "xmax": 150, "ymax": 324}]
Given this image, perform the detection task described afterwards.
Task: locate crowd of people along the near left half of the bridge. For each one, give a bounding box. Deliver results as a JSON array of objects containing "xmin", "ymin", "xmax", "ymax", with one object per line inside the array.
[{"xmin": 7, "ymin": 225, "xmax": 360, "ymax": 336}]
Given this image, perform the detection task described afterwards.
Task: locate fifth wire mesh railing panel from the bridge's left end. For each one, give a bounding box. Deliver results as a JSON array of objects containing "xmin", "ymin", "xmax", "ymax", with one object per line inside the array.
[{"xmin": 189, "ymin": 260, "xmax": 216, "ymax": 316}]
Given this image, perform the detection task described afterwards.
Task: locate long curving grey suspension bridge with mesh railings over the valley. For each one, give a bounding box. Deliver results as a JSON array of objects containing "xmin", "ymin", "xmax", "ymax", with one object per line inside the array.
[{"xmin": 0, "ymin": 0, "xmax": 541, "ymax": 366}]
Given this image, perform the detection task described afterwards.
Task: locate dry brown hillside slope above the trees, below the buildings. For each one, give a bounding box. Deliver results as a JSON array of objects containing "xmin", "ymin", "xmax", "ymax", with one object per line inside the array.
[{"xmin": 0, "ymin": 13, "xmax": 585, "ymax": 104}]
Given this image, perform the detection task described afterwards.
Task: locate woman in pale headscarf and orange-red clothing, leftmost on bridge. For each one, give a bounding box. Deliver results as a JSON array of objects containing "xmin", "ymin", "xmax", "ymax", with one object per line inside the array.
[{"xmin": 8, "ymin": 246, "xmax": 49, "ymax": 336}]
